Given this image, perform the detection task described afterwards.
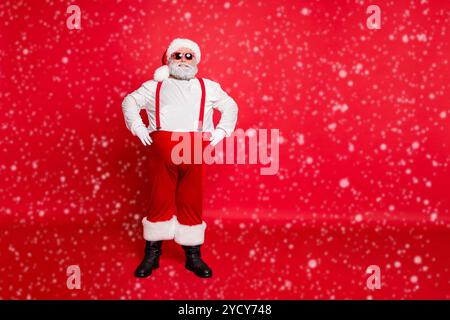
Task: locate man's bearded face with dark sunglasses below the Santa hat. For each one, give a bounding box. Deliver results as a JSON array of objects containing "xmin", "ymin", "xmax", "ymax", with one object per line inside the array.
[{"xmin": 169, "ymin": 48, "xmax": 198, "ymax": 80}]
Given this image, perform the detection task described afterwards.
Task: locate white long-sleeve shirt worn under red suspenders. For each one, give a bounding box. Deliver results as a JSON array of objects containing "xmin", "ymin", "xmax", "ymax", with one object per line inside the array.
[{"xmin": 122, "ymin": 78, "xmax": 238, "ymax": 137}]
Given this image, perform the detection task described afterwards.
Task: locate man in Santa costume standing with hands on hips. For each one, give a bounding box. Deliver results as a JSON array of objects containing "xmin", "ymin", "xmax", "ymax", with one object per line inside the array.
[{"xmin": 122, "ymin": 39, "xmax": 238, "ymax": 278}]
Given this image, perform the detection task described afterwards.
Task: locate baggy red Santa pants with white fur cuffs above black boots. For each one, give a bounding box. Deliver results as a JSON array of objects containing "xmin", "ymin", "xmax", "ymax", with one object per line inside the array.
[{"xmin": 142, "ymin": 130, "xmax": 209, "ymax": 246}]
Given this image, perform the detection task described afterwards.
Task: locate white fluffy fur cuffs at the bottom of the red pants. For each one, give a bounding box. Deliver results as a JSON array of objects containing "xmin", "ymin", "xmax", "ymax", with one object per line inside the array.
[{"xmin": 142, "ymin": 215, "xmax": 206, "ymax": 246}]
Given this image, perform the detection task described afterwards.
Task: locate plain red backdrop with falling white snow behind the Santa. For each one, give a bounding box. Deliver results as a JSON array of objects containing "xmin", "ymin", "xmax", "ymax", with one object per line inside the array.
[{"xmin": 0, "ymin": 0, "xmax": 450, "ymax": 299}]
